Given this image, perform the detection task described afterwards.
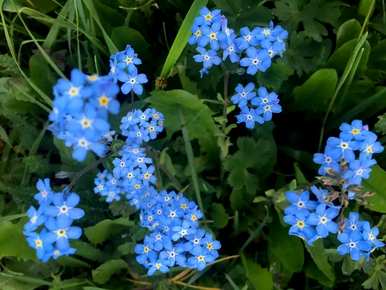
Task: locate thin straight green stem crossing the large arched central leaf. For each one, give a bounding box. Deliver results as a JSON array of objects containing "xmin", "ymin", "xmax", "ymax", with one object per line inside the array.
[{"xmin": 178, "ymin": 110, "xmax": 205, "ymax": 216}]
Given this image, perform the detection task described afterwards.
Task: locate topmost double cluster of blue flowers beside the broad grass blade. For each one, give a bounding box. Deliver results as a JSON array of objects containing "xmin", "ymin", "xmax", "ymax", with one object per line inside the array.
[{"xmin": 189, "ymin": 7, "xmax": 288, "ymax": 76}]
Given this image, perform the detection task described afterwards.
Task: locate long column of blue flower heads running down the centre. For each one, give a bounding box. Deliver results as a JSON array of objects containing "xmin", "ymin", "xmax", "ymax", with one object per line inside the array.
[{"xmin": 94, "ymin": 109, "xmax": 220, "ymax": 275}]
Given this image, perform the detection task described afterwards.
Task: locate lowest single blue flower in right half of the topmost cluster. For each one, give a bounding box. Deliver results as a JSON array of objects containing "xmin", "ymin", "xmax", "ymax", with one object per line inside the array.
[{"xmin": 240, "ymin": 47, "xmax": 271, "ymax": 75}]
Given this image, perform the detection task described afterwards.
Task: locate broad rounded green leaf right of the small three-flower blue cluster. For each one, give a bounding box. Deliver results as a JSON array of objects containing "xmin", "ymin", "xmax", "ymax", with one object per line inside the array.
[{"xmin": 293, "ymin": 68, "xmax": 338, "ymax": 112}]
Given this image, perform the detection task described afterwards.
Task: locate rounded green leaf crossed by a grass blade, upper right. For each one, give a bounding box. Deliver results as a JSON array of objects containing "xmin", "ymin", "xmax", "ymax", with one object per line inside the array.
[{"xmin": 327, "ymin": 39, "xmax": 371, "ymax": 74}]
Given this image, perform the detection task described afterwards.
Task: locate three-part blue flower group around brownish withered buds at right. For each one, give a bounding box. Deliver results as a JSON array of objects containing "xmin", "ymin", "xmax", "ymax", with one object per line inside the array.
[{"xmin": 284, "ymin": 120, "xmax": 384, "ymax": 261}]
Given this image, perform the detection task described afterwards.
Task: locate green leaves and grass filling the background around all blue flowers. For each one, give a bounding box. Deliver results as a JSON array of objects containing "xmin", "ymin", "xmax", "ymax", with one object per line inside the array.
[{"xmin": 0, "ymin": 0, "xmax": 386, "ymax": 290}]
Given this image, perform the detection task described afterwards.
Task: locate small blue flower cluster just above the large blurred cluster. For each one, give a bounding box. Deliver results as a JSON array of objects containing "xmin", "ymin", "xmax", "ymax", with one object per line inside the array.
[{"xmin": 110, "ymin": 44, "xmax": 148, "ymax": 95}]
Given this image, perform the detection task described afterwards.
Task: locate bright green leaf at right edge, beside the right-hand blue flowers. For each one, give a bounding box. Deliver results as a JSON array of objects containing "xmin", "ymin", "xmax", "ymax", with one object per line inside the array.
[{"xmin": 363, "ymin": 165, "xmax": 386, "ymax": 213}]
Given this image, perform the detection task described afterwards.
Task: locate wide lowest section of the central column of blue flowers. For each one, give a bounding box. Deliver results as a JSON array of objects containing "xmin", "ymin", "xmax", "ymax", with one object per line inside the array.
[{"xmin": 135, "ymin": 191, "xmax": 221, "ymax": 275}]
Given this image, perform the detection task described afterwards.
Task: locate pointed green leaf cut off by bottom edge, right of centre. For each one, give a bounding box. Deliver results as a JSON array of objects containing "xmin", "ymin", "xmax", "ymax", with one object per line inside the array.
[{"xmin": 241, "ymin": 255, "xmax": 273, "ymax": 290}]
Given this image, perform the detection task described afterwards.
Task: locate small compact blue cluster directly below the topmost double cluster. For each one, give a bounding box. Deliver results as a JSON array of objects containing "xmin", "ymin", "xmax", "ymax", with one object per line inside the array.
[{"xmin": 231, "ymin": 83, "xmax": 281, "ymax": 129}]
